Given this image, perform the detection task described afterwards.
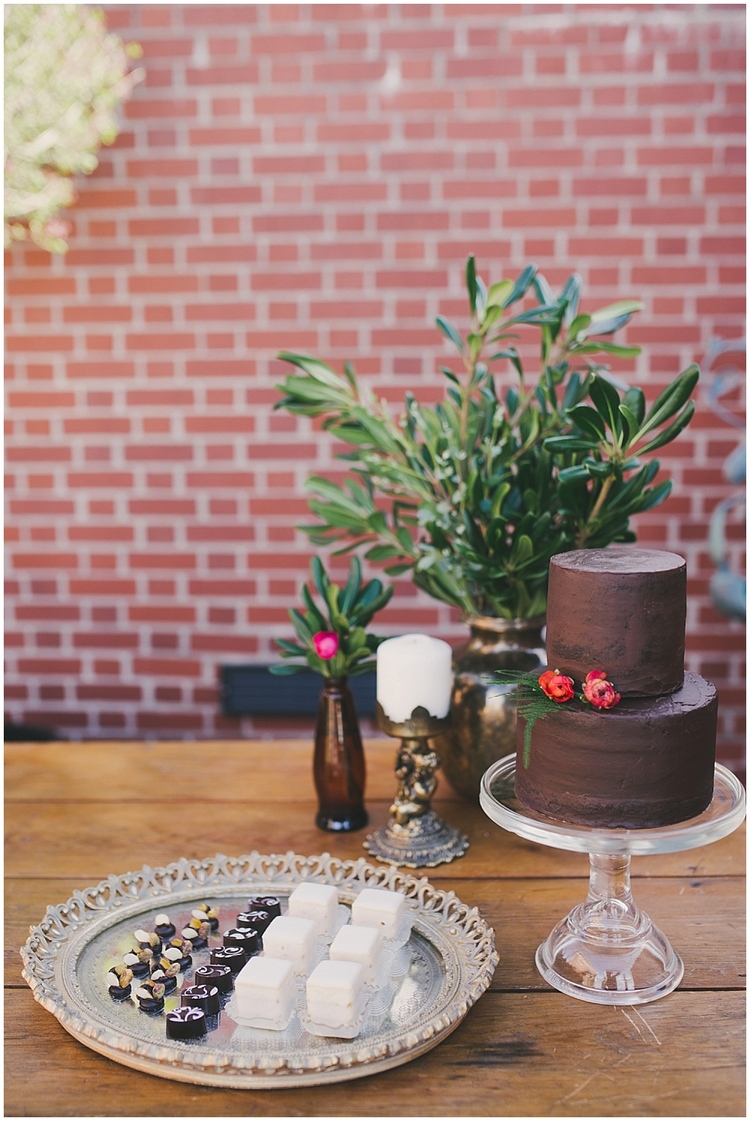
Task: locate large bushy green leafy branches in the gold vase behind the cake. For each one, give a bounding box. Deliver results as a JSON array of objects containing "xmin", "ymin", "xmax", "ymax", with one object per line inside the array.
[{"xmin": 276, "ymin": 257, "xmax": 698, "ymax": 618}]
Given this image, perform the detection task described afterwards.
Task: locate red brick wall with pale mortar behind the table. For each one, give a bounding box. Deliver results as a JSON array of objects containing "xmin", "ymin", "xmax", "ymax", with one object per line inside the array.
[{"xmin": 6, "ymin": 4, "xmax": 744, "ymax": 761}]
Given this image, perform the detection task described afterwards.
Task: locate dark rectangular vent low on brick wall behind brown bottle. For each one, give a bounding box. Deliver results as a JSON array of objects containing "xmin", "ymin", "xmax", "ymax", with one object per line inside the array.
[{"xmin": 219, "ymin": 666, "xmax": 376, "ymax": 716}]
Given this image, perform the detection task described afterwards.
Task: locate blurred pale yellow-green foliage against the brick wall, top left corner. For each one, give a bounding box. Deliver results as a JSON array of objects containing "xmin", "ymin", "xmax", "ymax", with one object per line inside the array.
[{"xmin": 4, "ymin": 3, "xmax": 140, "ymax": 252}]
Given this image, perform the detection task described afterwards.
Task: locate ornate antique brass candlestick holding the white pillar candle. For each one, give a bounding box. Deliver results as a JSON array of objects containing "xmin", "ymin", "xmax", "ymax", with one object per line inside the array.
[{"xmin": 364, "ymin": 704, "xmax": 469, "ymax": 868}]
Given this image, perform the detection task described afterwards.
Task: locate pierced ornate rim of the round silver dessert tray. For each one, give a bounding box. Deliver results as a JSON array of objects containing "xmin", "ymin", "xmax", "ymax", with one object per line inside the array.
[{"xmin": 20, "ymin": 851, "xmax": 498, "ymax": 1088}]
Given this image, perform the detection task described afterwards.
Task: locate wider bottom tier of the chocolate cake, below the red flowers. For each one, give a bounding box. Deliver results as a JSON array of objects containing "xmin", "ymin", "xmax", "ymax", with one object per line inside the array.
[{"xmin": 516, "ymin": 674, "xmax": 717, "ymax": 828}]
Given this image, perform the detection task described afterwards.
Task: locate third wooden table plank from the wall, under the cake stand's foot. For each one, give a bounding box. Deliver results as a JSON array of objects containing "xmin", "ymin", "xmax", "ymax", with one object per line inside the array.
[{"xmin": 4, "ymin": 878, "xmax": 746, "ymax": 991}]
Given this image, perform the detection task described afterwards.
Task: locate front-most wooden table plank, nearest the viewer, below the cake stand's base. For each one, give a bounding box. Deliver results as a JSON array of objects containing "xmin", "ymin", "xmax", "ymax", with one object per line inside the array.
[{"xmin": 4, "ymin": 991, "xmax": 744, "ymax": 1118}]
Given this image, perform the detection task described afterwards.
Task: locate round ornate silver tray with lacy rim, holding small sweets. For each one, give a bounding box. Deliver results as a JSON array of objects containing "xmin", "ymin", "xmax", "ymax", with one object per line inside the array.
[{"xmin": 21, "ymin": 852, "xmax": 498, "ymax": 1088}]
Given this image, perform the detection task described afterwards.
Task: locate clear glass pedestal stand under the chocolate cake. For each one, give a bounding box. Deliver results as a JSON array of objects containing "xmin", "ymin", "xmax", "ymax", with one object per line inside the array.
[{"xmin": 479, "ymin": 754, "xmax": 744, "ymax": 1004}]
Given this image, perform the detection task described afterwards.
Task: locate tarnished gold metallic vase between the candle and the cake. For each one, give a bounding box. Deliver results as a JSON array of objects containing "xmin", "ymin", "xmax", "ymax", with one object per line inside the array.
[{"xmin": 434, "ymin": 615, "xmax": 546, "ymax": 802}]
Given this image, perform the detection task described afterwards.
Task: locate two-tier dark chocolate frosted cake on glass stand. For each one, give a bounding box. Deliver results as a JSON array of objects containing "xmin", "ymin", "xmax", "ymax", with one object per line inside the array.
[{"xmin": 516, "ymin": 548, "xmax": 717, "ymax": 828}]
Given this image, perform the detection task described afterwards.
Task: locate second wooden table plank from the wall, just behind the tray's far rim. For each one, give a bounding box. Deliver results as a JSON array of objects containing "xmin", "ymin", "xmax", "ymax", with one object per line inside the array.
[{"xmin": 4, "ymin": 800, "xmax": 744, "ymax": 882}]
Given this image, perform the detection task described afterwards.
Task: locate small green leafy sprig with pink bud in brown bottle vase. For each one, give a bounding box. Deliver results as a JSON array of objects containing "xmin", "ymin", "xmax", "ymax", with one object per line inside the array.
[{"xmin": 268, "ymin": 557, "xmax": 393, "ymax": 677}]
